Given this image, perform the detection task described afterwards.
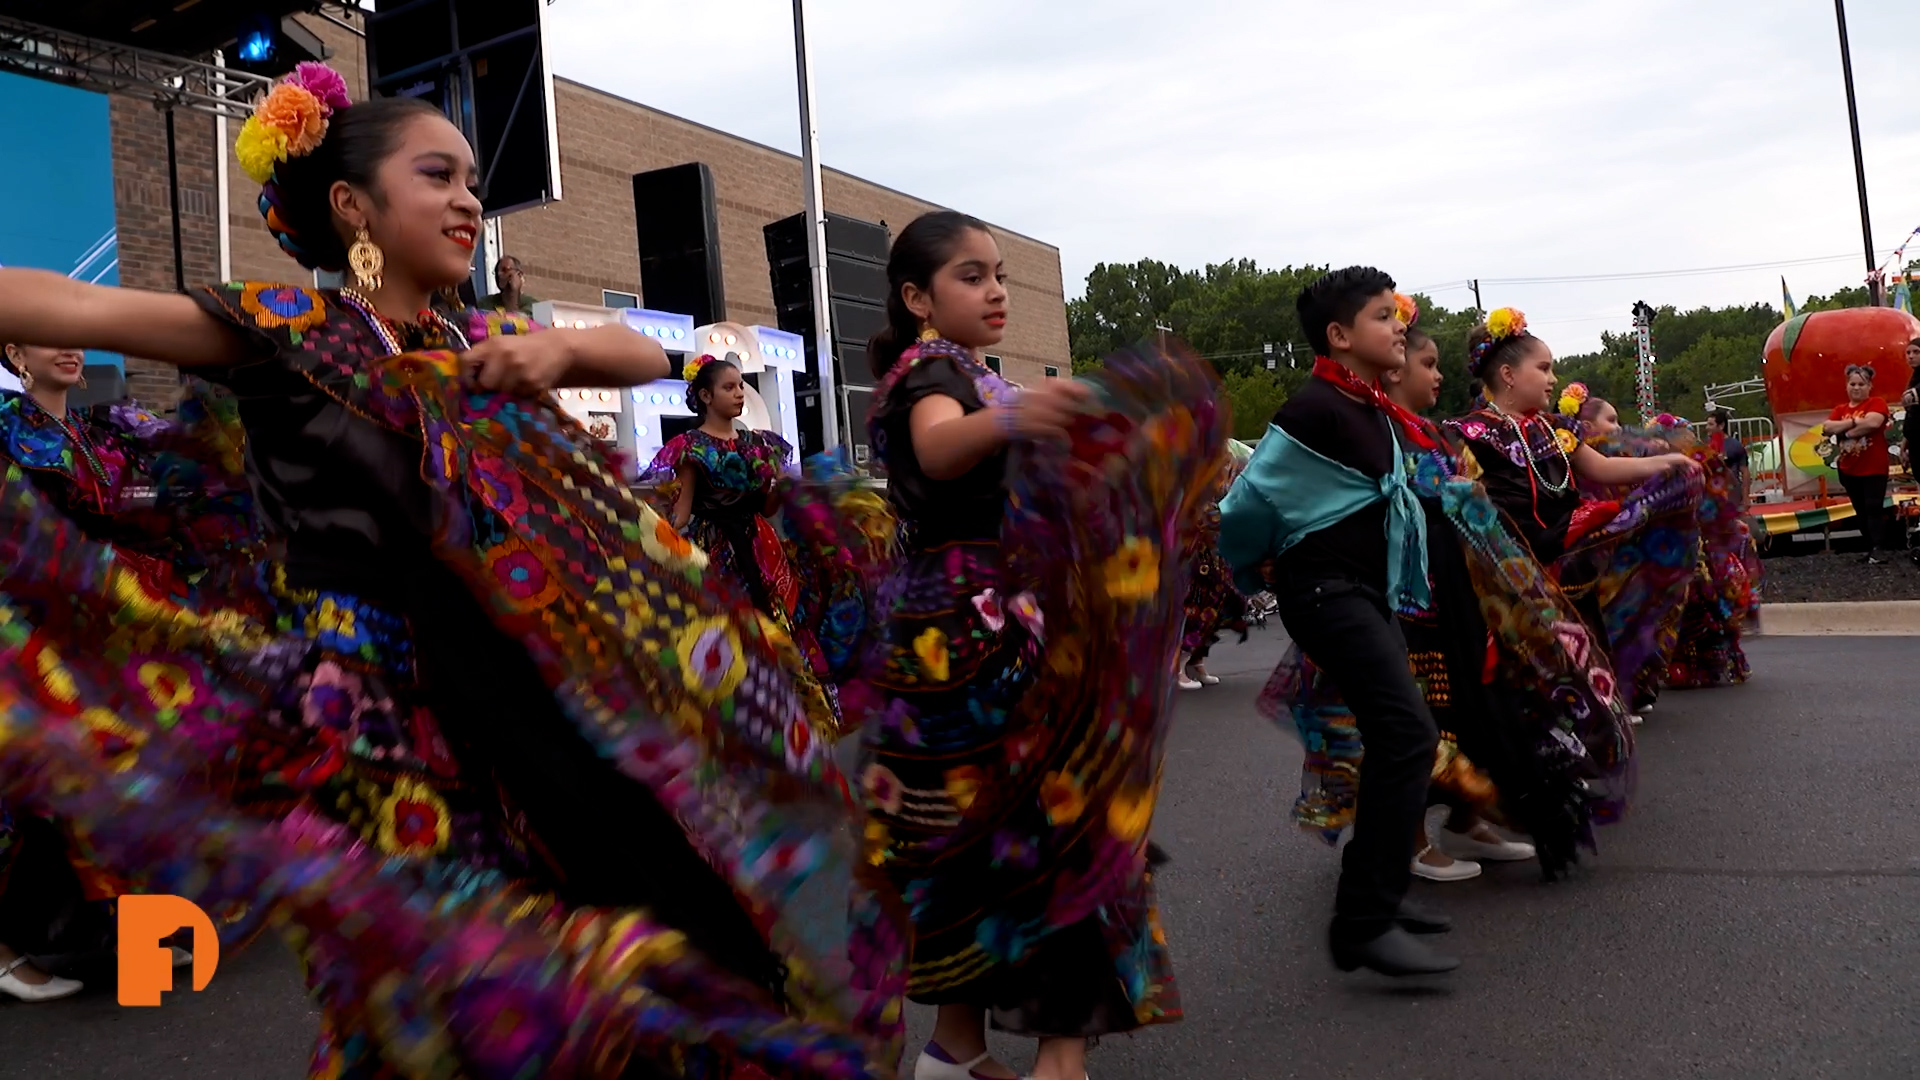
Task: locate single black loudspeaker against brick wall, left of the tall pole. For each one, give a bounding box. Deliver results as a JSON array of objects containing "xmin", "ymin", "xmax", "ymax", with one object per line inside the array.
[{"xmin": 634, "ymin": 161, "xmax": 726, "ymax": 327}]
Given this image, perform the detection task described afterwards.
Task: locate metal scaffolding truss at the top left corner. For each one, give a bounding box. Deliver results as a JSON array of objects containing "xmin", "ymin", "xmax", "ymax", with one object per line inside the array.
[{"xmin": 0, "ymin": 15, "xmax": 273, "ymax": 119}]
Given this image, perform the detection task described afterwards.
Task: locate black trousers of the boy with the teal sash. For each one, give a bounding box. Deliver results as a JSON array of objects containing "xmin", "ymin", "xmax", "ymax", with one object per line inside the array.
[{"xmin": 1281, "ymin": 580, "xmax": 1440, "ymax": 944}]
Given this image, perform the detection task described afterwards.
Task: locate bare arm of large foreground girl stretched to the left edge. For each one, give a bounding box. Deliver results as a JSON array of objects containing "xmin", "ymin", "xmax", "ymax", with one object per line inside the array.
[{"xmin": 0, "ymin": 269, "xmax": 248, "ymax": 367}]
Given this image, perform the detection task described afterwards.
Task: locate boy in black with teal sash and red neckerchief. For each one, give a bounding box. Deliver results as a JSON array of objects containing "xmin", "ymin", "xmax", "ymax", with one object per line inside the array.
[{"xmin": 1219, "ymin": 267, "xmax": 1459, "ymax": 974}]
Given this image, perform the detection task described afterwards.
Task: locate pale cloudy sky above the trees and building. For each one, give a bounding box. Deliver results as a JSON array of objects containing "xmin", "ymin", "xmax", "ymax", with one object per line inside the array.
[{"xmin": 549, "ymin": 0, "xmax": 1920, "ymax": 352}]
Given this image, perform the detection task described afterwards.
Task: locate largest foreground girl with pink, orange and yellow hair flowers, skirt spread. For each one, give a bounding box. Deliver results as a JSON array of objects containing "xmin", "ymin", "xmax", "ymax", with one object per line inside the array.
[{"xmin": 0, "ymin": 65, "xmax": 899, "ymax": 1076}]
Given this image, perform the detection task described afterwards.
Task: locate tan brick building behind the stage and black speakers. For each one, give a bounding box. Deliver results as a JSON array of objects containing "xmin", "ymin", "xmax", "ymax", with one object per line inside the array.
[{"xmin": 111, "ymin": 17, "xmax": 1069, "ymax": 405}]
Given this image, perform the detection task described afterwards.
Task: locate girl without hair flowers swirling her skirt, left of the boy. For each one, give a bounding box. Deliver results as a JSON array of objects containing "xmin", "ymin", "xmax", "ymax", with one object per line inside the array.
[{"xmin": 860, "ymin": 211, "xmax": 1225, "ymax": 1080}]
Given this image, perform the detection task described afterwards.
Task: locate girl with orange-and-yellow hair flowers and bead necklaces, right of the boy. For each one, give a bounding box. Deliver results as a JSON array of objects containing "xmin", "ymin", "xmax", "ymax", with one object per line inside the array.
[{"xmin": 1446, "ymin": 307, "xmax": 1701, "ymax": 705}]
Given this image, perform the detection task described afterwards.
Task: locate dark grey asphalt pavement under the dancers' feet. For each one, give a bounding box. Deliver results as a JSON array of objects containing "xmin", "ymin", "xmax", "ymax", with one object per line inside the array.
[{"xmin": 0, "ymin": 628, "xmax": 1920, "ymax": 1080}]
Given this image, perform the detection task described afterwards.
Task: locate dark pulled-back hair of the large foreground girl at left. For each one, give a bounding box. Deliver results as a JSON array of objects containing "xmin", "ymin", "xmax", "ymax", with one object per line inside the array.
[{"xmin": 259, "ymin": 98, "xmax": 442, "ymax": 271}]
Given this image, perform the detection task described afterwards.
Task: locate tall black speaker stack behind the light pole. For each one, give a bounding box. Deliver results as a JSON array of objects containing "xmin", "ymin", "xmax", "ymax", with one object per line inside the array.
[{"xmin": 766, "ymin": 213, "xmax": 893, "ymax": 463}]
